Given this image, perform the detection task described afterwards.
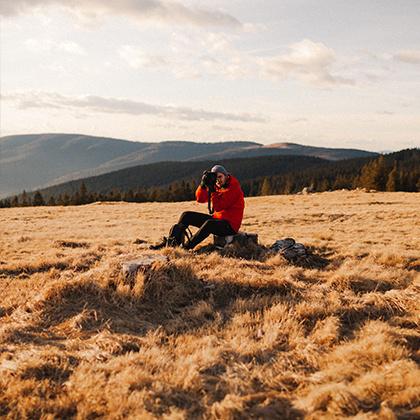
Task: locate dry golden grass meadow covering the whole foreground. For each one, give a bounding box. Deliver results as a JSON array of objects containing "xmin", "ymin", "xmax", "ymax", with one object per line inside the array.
[{"xmin": 0, "ymin": 191, "xmax": 420, "ymax": 419}]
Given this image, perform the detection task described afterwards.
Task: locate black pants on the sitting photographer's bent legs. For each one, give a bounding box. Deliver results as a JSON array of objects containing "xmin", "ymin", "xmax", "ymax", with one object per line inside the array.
[{"xmin": 178, "ymin": 211, "xmax": 236, "ymax": 249}]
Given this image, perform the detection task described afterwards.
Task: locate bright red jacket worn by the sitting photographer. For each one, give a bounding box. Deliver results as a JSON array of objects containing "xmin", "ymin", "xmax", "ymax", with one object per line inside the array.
[{"xmin": 195, "ymin": 175, "xmax": 245, "ymax": 232}]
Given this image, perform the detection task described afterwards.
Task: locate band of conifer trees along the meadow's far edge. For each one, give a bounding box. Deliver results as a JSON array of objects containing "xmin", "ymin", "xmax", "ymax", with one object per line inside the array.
[{"xmin": 0, "ymin": 149, "xmax": 420, "ymax": 208}]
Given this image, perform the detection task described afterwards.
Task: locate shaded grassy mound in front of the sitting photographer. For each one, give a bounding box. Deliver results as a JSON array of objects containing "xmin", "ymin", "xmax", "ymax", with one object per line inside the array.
[{"xmin": 4, "ymin": 262, "xmax": 302, "ymax": 346}]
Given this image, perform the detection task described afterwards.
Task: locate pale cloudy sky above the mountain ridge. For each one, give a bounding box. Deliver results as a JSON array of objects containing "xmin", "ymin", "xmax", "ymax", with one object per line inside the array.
[{"xmin": 0, "ymin": 0, "xmax": 420, "ymax": 151}]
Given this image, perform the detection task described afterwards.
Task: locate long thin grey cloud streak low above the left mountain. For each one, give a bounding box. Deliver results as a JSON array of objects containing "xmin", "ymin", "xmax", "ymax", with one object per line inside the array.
[{"xmin": 1, "ymin": 92, "xmax": 265, "ymax": 123}]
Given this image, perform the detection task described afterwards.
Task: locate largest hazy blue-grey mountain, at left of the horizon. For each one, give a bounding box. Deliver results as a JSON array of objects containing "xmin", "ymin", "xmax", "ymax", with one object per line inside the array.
[{"xmin": 0, "ymin": 134, "xmax": 256, "ymax": 195}]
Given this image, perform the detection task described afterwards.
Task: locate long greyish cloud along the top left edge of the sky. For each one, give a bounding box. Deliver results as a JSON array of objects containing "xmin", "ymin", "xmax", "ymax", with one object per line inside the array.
[{"xmin": 0, "ymin": 0, "xmax": 242, "ymax": 27}]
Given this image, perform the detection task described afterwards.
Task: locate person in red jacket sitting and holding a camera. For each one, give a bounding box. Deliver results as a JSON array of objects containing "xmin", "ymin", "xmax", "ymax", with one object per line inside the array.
[{"xmin": 150, "ymin": 165, "xmax": 245, "ymax": 249}]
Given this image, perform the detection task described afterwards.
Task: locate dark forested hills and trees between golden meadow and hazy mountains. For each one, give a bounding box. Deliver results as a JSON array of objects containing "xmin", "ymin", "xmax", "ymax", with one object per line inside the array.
[{"xmin": 0, "ymin": 149, "xmax": 420, "ymax": 207}]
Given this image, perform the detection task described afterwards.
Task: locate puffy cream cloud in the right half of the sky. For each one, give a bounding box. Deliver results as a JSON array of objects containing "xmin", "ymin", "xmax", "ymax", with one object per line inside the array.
[{"xmin": 260, "ymin": 39, "xmax": 354, "ymax": 86}]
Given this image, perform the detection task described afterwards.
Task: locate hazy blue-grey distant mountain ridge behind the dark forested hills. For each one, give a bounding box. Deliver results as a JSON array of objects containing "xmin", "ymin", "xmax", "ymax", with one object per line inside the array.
[{"xmin": 0, "ymin": 134, "xmax": 377, "ymax": 196}]
